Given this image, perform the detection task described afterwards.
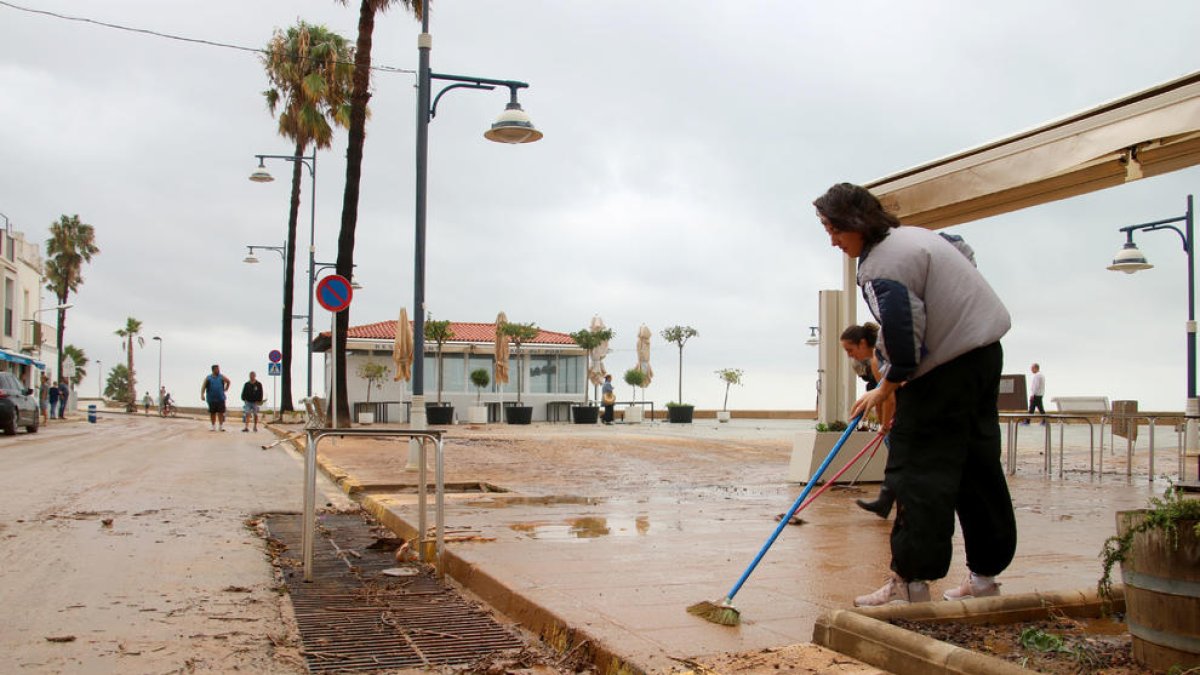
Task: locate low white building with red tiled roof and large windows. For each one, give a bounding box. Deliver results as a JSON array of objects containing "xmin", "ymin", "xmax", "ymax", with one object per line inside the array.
[{"xmin": 313, "ymin": 321, "xmax": 588, "ymax": 422}]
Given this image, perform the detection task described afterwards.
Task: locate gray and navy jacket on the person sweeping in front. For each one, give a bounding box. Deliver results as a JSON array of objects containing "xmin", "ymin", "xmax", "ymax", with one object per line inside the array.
[{"xmin": 858, "ymin": 226, "xmax": 1012, "ymax": 383}]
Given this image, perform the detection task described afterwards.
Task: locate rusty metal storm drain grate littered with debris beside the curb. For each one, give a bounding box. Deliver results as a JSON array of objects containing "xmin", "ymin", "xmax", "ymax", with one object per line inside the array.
[{"xmin": 265, "ymin": 514, "xmax": 523, "ymax": 673}]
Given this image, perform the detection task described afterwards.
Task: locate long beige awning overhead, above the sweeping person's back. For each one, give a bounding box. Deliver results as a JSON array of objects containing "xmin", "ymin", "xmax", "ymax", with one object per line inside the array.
[{"xmin": 866, "ymin": 72, "xmax": 1200, "ymax": 229}]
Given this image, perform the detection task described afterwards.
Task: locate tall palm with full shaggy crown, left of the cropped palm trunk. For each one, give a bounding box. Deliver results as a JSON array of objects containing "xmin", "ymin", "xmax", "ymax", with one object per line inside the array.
[{"xmin": 263, "ymin": 22, "xmax": 354, "ymax": 411}]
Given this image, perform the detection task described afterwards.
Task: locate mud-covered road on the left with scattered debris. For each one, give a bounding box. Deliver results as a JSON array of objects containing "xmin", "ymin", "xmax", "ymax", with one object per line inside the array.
[{"xmin": 0, "ymin": 414, "xmax": 348, "ymax": 673}]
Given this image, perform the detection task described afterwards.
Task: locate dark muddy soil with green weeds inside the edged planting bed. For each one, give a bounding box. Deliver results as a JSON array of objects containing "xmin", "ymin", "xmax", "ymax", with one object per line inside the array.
[{"xmin": 892, "ymin": 617, "xmax": 1152, "ymax": 675}]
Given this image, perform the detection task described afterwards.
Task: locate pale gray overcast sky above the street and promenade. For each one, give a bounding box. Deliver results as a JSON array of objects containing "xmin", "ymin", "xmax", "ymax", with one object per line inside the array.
[{"xmin": 0, "ymin": 0, "xmax": 1200, "ymax": 410}]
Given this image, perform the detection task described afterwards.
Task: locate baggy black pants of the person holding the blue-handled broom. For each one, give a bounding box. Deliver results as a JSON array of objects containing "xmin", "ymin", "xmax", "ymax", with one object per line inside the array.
[{"xmin": 884, "ymin": 342, "xmax": 1016, "ymax": 580}]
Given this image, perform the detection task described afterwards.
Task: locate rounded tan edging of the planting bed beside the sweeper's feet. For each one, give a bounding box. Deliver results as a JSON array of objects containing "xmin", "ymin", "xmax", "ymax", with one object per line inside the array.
[{"xmin": 812, "ymin": 587, "xmax": 1124, "ymax": 675}]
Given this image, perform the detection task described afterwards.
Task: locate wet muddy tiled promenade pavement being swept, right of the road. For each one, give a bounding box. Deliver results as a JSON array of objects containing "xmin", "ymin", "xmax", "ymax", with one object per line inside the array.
[{"xmin": 295, "ymin": 419, "xmax": 1195, "ymax": 671}]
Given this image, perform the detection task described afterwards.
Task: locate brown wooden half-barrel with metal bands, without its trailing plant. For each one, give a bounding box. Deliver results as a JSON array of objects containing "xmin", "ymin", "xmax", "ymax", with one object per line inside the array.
[{"xmin": 1117, "ymin": 510, "xmax": 1200, "ymax": 671}]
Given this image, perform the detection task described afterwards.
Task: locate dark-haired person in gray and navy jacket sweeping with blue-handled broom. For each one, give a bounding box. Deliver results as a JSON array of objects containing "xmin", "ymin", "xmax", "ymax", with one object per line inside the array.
[{"xmin": 814, "ymin": 183, "xmax": 1016, "ymax": 607}]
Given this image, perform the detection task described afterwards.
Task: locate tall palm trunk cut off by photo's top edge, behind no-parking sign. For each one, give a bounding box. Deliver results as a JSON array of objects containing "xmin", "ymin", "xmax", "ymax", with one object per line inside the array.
[{"xmin": 331, "ymin": 0, "xmax": 425, "ymax": 420}]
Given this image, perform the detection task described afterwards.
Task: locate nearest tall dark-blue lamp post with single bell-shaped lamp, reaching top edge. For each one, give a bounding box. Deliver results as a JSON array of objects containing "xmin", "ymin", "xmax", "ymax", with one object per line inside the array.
[{"xmin": 412, "ymin": 0, "xmax": 542, "ymax": 439}]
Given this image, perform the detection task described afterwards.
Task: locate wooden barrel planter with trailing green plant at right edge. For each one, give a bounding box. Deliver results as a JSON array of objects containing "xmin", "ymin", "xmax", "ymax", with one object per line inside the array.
[{"xmin": 1098, "ymin": 484, "xmax": 1200, "ymax": 671}]
